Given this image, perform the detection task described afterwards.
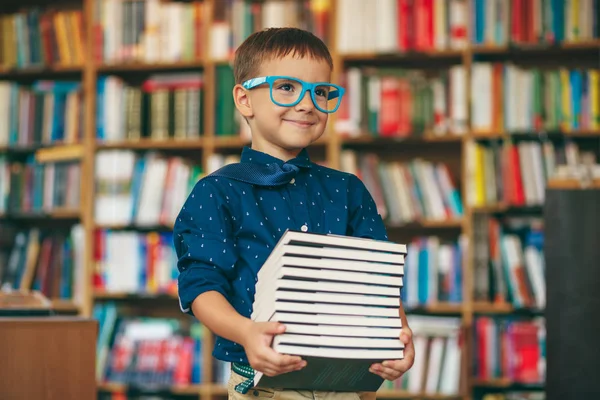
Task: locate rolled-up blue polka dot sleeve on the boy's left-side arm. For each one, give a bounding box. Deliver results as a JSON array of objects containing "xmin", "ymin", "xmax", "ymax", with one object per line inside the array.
[{"xmin": 173, "ymin": 178, "xmax": 237, "ymax": 315}]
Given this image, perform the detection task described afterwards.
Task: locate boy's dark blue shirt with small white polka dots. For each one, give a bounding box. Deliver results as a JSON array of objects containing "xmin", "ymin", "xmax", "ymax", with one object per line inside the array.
[{"xmin": 173, "ymin": 147, "xmax": 388, "ymax": 363}]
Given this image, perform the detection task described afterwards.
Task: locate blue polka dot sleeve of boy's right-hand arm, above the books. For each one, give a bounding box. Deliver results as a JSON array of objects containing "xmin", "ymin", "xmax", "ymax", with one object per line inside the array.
[{"xmin": 348, "ymin": 175, "xmax": 388, "ymax": 241}]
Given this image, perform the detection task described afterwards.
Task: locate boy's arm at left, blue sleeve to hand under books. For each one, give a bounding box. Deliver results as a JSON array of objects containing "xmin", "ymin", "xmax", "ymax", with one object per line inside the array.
[{"xmin": 173, "ymin": 179, "xmax": 304, "ymax": 376}]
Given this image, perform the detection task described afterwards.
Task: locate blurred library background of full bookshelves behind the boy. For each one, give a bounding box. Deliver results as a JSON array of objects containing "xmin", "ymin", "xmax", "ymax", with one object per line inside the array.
[{"xmin": 0, "ymin": 0, "xmax": 600, "ymax": 400}]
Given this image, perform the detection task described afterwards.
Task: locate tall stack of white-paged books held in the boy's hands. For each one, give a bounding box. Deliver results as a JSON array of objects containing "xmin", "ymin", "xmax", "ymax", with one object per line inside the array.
[{"xmin": 251, "ymin": 230, "xmax": 406, "ymax": 392}]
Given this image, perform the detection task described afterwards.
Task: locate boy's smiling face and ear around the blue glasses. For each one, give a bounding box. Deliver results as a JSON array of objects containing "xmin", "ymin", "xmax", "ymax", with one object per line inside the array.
[{"xmin": 234, "ymin": 54, "xmax": 331, "ymax": 160}]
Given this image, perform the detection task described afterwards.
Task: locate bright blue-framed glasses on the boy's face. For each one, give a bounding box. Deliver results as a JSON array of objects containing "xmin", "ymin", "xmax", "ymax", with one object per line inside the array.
[{"xmin": 242, "ymin": 76, "xmax": 344, "ymax": 113}]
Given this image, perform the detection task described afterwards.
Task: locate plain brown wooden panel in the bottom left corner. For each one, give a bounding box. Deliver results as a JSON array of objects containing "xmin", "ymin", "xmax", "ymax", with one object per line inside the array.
[{"xmin": 0, "ymin": 317, "xmax": 98, "ymax": 400}]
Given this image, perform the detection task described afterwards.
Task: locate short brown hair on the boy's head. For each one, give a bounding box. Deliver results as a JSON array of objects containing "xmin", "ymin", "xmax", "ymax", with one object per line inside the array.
[{"xmin": 233, "ymin": 28, "xmax": 333, "ymax": 83}]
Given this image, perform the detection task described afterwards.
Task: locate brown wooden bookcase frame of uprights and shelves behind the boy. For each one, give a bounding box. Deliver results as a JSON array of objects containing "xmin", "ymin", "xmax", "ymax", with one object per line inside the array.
[{"xmin": 0, "ymin": 0, "xmax": 600, "ymax": 400}]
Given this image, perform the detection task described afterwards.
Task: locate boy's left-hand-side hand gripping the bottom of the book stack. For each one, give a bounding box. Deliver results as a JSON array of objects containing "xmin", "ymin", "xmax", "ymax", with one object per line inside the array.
[{"xmin": 243, "ymin": 321, "xmax": 306, "ymax": 376}]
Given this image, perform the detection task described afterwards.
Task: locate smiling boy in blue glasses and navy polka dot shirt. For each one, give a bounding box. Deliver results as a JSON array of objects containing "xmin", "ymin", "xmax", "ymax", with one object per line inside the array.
[{"xmin": 174, "ymin": 28, "xmax": 414, "ymax": 399}]
